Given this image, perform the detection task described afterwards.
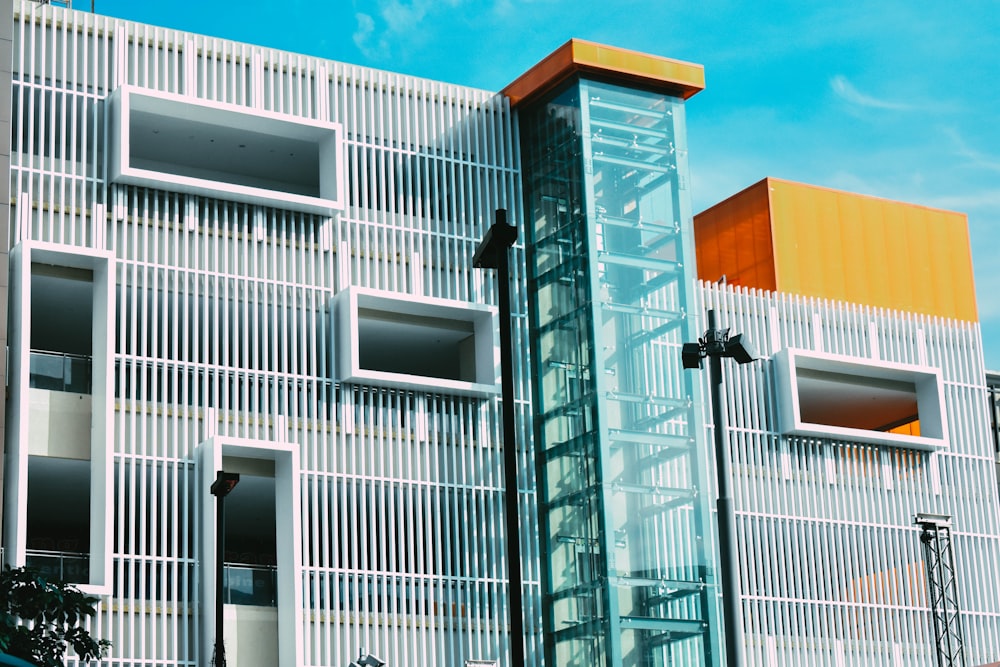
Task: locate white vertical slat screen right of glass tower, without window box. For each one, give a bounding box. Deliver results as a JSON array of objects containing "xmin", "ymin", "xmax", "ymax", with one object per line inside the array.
[{"xmin": 700, "ymin": 284, "xmax": 1000, "ymax": 667}]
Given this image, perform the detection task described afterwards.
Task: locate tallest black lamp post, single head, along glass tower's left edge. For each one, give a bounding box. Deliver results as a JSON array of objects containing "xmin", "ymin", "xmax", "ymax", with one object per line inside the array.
[{"xmin": 472, "ymin": 208, "xmax": 525, "ymax": 667}]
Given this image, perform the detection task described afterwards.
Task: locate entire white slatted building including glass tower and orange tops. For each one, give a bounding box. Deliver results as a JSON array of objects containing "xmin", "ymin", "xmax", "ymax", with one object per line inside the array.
[{"xmin": 0, "ymin": 2, "xmax": 1000, "ymax": 667}]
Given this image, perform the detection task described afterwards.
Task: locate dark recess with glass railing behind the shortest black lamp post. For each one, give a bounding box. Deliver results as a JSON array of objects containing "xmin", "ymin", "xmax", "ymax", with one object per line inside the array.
[{"xmin": 223, "ymin": 468, "xmax": 278, "ymax": 607}]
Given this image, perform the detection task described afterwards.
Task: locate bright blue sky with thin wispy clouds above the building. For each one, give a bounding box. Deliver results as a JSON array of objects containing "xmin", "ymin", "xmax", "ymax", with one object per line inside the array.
[{"xmin": 94, "ymin": 0, "xmax": 1000, "ymax": 369}]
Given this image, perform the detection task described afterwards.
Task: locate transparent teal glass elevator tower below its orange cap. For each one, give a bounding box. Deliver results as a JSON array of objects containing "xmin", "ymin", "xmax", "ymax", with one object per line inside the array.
[{"xmin": 520, "ymin": 78, "xmax": 719, "ymax": 667}]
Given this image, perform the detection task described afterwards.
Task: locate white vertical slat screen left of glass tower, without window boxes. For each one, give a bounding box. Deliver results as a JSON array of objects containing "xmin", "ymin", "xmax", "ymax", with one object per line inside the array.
[{"xmin": 7, "ymin": 2, "xmax": 540, "ymax": 666}]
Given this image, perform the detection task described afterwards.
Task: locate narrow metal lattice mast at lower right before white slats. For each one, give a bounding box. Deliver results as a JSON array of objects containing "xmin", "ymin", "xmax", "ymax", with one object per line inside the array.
[{"xmin": 914, "ymin": 514, "xmax": 965, "ymax": 667}]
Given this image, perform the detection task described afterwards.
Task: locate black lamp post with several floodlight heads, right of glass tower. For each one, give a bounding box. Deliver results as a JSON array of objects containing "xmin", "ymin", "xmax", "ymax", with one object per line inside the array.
[{"xmin": 681, "ymin": 310, "xmax": 756, "ymax": 667}]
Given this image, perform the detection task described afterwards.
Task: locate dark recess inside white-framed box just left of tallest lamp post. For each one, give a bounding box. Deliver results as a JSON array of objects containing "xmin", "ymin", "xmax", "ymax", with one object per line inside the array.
[{"xmin": 358, "ymin": 308, "xmax": 476, "ymax": 382}]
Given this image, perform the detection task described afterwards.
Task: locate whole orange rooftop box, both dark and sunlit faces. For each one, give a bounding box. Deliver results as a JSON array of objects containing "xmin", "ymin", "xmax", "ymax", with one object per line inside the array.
[{"xmin": 694, "ymin": 178, "xmax": 979, "ymax": 321}]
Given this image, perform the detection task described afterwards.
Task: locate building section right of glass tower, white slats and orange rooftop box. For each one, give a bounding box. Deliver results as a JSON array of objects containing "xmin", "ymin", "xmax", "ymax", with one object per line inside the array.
[{"xmin": 695, "ymin": 179, "xmax": 1000, "ymax": 665}]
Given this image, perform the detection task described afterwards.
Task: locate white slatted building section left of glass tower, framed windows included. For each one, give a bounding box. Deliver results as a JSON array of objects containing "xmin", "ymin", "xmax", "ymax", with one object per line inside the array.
[{"xmin": 4, "ymin": 2, "xmax": 540, "ymax": 666}]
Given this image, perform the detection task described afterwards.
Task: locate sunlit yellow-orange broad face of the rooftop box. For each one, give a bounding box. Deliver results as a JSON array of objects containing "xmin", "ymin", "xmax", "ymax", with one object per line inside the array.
[{"xmin": 767, "ymin": 179, "xmax": 978, "ymax": 321}]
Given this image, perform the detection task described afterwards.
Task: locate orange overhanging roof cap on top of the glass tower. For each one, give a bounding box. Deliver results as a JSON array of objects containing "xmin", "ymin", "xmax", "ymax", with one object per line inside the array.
[{"xmin": 502, "ymin": 39, "xmax": 705, "ymax": 107}]
